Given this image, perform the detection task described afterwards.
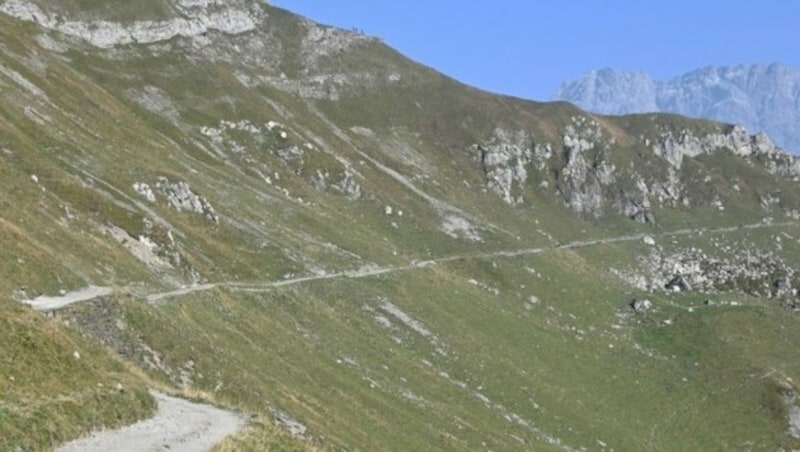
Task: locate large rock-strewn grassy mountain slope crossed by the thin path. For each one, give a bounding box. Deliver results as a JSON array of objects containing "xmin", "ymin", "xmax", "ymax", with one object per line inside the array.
[{"xmin": 0, "ymin": 0, "xmax": 800, "ymax": 450}]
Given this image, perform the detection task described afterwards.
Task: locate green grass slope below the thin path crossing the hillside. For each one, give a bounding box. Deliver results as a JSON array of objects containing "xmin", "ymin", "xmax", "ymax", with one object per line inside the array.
[{"xmin": 56, "ymin": 247, "xmax": 797, "ymax": 450}]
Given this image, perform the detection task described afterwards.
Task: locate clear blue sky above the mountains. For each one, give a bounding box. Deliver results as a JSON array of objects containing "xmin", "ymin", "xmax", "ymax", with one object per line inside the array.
[{"xmin": 270, "ymin": 0, "xmax": 800, "ymax": 100}]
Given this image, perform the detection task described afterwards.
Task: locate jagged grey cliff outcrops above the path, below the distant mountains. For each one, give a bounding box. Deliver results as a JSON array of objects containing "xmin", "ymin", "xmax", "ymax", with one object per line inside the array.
[{"xmin": 472, "ymin": 115, "xmax": 800, "ymax": 224}]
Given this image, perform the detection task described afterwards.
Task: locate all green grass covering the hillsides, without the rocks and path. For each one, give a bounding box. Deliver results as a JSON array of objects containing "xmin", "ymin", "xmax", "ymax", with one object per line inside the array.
[{"xmin": 0, "ymin": 1, "xmax": 800, "ymax": 450}]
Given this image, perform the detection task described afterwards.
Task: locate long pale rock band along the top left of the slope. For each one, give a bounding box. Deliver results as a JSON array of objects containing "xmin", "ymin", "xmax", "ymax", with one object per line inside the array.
[{"xmin": 0, "ymin": 0, "xmax": 263, "ymax": 48}]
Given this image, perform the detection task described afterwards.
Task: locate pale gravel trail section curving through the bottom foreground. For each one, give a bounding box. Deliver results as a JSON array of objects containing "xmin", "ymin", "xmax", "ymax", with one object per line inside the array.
[{"xmin": 56, "ymin": 391, "xmax": 245, "ymax": 452}]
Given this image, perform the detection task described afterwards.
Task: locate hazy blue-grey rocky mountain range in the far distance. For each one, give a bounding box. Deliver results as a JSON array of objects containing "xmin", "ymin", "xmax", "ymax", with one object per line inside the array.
[{"xmin": 553, "ymin": 63, "xmax": 800, "ymax": 153}]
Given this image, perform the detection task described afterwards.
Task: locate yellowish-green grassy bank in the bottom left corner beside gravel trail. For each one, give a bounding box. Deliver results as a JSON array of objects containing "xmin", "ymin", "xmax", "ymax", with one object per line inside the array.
[{"xmin": 0, "ymin": 298, "xmax": 155, "ymax": 450}]
